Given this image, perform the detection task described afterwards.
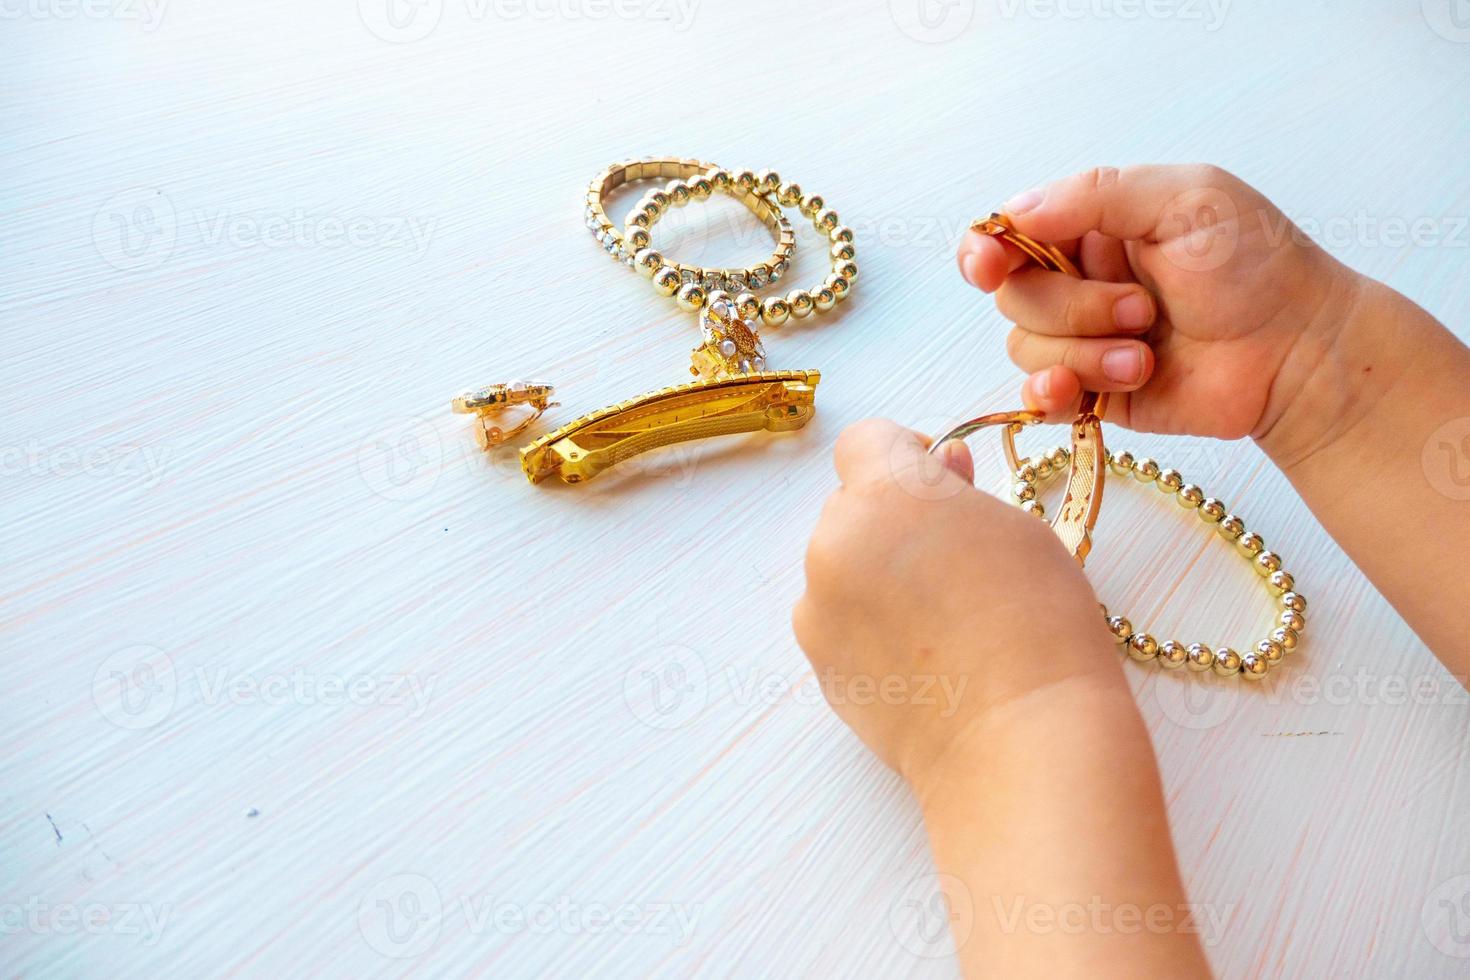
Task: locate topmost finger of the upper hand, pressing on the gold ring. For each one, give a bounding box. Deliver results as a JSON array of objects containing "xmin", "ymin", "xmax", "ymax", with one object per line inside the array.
[{"xmin": 1005, "ymin": 166, "xmax": 1239, "ymax": 241}]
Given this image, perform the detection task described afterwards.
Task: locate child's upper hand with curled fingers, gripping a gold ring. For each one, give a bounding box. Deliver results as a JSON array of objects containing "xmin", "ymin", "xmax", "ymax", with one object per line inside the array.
[{"xmin": 958, "ymin": 166, "xmax": 1360, "ymax": 452}]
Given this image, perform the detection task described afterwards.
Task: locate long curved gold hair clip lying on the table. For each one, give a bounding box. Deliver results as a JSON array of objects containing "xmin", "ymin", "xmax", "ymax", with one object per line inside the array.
[{"xmin": 520, "ymin": 370, "xmax": 822, "ymax": 483}]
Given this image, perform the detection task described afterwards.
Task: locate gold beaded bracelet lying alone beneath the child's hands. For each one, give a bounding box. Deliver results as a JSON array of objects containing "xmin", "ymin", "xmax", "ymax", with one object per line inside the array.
[{"xmin": 1011, "ymin": 447, "xmax": 1307, "ymax": 680}]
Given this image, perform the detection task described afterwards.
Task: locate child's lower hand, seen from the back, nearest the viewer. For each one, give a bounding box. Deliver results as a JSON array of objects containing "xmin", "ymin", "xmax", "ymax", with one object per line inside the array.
[{"xmin": 792, "ymin": 419, "xmax": 1136, "ymax": 792}]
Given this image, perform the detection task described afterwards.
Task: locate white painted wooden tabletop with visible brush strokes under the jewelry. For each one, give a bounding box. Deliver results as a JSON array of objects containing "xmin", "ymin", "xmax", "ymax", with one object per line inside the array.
[{"xmin": 0, "ymin": 0, "xmax": 1470, "ymax": 977}]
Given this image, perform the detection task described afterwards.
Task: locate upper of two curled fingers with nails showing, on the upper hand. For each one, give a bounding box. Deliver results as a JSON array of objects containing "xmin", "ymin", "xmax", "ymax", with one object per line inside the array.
[{"xmin": 995, "ymin": 267, "xmax": 1158, "ymax": 336}]
